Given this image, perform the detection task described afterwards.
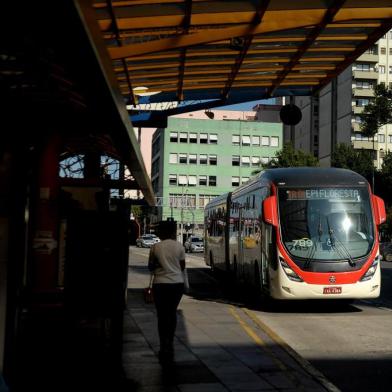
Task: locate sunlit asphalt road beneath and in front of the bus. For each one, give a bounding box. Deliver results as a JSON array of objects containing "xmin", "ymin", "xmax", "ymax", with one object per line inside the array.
[{"xmin": 130, "ymin": 250, "xmax": 392, "ymax": 392}]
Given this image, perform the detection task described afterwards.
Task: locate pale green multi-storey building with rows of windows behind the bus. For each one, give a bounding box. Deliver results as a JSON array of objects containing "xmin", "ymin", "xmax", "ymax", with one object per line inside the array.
[{"xmin": 151, "ymin": 110, "xmax": 283, "ymax": 233}]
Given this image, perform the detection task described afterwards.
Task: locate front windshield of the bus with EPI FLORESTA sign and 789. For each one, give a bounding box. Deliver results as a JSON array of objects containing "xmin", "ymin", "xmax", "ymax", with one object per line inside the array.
[{"xmin": 278, "ymin": 187, "xmax": 374, "ymax": 262}]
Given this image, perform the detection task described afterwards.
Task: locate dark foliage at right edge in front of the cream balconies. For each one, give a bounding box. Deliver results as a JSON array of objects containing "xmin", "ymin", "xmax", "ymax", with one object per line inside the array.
[{"xmin": 360, "ymin": 84, "xmax": 392, "ymax": 137}]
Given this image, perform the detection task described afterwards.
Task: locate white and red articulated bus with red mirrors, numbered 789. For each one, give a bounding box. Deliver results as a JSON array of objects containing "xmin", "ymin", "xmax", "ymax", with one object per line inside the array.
[{"xmin": 204, "ymin": 167, "xmax": 386, "ymax": 300}]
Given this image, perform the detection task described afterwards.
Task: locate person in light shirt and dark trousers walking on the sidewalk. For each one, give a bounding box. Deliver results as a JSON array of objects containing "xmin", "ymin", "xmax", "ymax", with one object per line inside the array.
[{"xmin": 148, "ymin": 221, "xmax": 185, "ymax": 365}]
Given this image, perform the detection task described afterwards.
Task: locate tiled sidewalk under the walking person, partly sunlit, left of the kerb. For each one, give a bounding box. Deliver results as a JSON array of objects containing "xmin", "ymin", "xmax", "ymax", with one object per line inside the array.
[{"xmin": 123, "ymin": 258, "xmax": 337, "ymax": 392}]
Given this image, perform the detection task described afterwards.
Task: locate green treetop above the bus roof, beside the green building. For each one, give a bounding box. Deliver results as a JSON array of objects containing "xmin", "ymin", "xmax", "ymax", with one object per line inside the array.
[{"xmin": 262, "ymin": 143, "xmax": 319, "ymax": 169}]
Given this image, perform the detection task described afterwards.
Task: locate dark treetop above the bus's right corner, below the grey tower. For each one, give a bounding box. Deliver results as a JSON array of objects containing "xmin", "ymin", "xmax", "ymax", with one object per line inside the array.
[{"xmin": 331, "ymin": 143, "xmax": 374, "ymax": 181}]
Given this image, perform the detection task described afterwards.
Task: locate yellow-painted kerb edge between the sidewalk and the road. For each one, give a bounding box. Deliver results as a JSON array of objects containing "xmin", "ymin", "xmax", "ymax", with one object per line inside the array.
[{"xmin": 243, "ymin": 308, "xmax": 341, "ymax": 392}]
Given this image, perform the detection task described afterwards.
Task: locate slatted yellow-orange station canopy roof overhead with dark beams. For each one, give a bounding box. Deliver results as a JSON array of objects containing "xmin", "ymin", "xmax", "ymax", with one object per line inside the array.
[{"xmin": 93, "ymin": 0, "xmax": 392, "ymax": 125}]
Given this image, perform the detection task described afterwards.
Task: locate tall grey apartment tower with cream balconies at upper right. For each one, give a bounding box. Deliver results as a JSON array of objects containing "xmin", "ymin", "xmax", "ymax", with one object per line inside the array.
[{"xmin": 284, "ymin": 32, "xmax": 392, "ymax": 167}]
